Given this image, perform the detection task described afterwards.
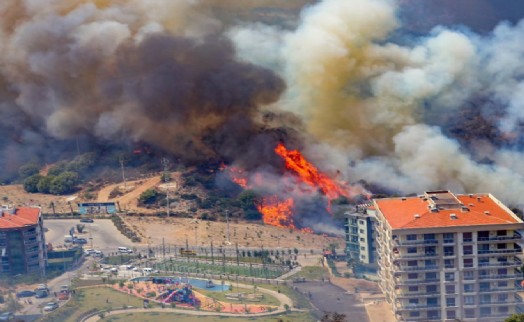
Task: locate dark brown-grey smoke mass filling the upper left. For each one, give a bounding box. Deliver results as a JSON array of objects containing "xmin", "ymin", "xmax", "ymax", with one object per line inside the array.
[{"xmin": 0, "ymin": 0, "xmax": 284, "ymax": 176}]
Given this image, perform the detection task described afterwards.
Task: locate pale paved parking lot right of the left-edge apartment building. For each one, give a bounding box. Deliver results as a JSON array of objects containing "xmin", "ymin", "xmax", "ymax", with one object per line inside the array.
[{"xmin": 44, "ymin": 219, "xmax": 137, "ymax": 253}]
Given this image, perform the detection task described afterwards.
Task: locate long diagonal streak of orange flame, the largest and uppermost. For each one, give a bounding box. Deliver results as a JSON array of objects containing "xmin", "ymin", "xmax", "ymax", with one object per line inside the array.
[{"xmin": 275, "ymin": 143, "xmax": 350, "ymax": 200}]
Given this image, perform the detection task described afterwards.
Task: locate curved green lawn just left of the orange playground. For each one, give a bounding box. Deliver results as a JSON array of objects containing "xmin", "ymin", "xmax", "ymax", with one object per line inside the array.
[{"xmin": 40, "ymin": 287, "xmax": 149, "ymax": 322}]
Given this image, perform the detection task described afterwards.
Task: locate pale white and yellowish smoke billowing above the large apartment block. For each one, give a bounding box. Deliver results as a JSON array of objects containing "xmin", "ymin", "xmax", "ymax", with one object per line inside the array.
[{"xmin": 229, "ymin": 0, "xmax": 524, "ymax": 205}]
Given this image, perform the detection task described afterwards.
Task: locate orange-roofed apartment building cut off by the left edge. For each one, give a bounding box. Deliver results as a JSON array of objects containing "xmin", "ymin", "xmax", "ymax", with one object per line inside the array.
[{"xmin": 0, "ymin": 207, "xmax": 47, "ymax": 275}]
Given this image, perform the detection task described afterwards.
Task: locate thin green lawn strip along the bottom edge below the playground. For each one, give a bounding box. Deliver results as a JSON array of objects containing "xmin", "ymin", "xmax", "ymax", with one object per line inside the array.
[{"xmin": 101, "ymin": 312, "xmax": 316, "ymax": 322}]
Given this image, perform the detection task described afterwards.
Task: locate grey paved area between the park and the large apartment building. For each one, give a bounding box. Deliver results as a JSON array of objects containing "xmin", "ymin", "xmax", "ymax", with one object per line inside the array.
[{"xmin": 293, "ymin": 282, "xmax": 369, "ymax": 322}]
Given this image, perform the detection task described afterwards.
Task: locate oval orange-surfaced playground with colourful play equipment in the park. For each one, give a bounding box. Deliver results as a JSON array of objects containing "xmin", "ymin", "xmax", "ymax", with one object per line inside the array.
[{"xmin": 113, "ymin": 277, "xmax": 279, "ymax": 314}]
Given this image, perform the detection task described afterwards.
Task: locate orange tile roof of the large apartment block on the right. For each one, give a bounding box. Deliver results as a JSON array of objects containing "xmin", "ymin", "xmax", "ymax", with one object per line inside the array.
[{"xmin": 375, "ymin": 192, "xmax": 522, "ymax": 229}]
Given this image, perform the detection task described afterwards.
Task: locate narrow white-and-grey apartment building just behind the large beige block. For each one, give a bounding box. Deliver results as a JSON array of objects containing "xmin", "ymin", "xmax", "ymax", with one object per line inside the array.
[{"xmin": 345, "ymin": 204, "xmax": 377, "ymax": 270}]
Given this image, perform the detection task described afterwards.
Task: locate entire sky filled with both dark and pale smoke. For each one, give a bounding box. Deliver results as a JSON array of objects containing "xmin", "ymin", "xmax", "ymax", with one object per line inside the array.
[{"xmin": 0, "ymin": 0, "xmax": 524, "ymax": 205}]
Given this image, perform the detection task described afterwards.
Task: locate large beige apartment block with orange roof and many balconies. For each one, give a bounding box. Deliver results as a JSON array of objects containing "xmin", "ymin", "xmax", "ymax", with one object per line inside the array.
[{"xmin": 374, "ymin": 191, "xmax": 524, "ymax": 322}]
